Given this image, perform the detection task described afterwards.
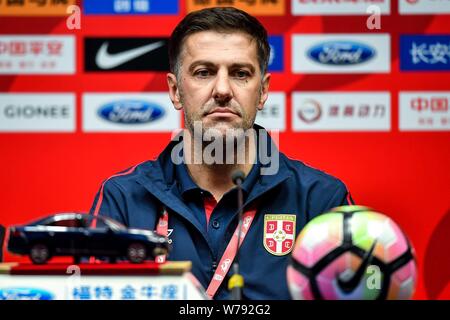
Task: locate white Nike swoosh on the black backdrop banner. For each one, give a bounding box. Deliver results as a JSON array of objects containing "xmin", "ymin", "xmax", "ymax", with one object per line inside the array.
[{"xmin": 95, "ymin": 41, "xmax": 164, "ymax": 69}]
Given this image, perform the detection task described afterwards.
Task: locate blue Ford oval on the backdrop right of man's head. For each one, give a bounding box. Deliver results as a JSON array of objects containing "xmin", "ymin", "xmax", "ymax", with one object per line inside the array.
[{"xmin": 307, "ymin": 41, "xmax": 376, "ymax": 66}]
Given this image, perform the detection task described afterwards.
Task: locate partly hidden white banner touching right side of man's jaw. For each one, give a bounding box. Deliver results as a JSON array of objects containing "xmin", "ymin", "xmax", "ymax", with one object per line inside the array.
[{"xmin": 255, "ymin": 92, "xmax": 286, "ymax": 131}]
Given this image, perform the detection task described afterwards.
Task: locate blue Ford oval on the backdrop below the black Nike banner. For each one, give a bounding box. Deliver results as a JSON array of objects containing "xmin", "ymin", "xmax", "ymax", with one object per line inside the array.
[{"xmin": 98, "ymin": 100, "xmax": 164, "ymax": 124}]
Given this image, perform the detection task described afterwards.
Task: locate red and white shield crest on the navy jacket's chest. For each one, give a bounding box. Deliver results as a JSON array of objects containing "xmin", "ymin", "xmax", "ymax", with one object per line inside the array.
[{"xmin": 263, "ymin": 214, "xmax": 296, "ymax": 256}]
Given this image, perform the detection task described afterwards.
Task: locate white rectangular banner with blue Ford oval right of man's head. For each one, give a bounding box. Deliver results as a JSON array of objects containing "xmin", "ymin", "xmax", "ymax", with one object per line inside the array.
[{"xmin": 292, "ymin": 34, "xmax": 391, "ymax": 73}]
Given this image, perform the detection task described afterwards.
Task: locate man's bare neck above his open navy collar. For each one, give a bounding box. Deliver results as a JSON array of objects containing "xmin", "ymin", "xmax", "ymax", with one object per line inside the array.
[{"xmin": 183, "ymin": 129, "xmax": 256, "ymax": 202}]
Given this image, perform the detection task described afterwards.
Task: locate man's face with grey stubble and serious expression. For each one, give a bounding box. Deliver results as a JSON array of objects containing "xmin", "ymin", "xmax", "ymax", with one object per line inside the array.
[{"xmin": 167, "ymin": 31, "xmax": 270, "ymax": 134}]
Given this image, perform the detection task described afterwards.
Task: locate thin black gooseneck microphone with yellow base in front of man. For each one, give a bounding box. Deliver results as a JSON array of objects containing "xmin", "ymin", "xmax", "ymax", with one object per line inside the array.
[{"xmin": 228, "ymin": 170, "xmax": 245, "ymax": 300}]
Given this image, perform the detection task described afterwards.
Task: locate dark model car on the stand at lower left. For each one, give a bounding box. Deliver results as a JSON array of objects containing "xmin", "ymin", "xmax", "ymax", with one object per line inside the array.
[{"xmin": 8, "ymin": 213, "xmax": 170, "ymax": 264}]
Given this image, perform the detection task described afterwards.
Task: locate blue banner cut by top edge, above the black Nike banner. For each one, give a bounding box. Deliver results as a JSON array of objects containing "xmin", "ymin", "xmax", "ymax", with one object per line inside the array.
[{"xmin": 83, "ymin": 0, "xmax": 178, "ymax": 15}]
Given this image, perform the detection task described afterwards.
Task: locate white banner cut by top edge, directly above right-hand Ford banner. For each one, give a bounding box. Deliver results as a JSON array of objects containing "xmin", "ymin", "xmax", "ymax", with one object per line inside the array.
[{"xmin": 292, "ymin": 0, "xmax": 391, "ymax": 16}]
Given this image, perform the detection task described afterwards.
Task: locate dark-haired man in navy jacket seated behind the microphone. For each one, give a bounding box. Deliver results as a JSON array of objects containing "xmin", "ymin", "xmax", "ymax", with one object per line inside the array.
[{"xmin": 91, "ymin": 8, "xmax": 350, "ymax": 299}]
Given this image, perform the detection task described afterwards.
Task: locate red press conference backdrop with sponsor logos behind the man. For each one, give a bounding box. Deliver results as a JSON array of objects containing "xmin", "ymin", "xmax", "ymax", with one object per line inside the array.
[{"xmin": 0, "ymin": 0, "xmax": 450, "ymax": 299}]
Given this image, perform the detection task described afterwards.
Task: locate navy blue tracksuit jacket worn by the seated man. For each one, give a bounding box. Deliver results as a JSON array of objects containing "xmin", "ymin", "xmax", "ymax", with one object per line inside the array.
[{"xmin": 91, "ymin": 125, "xmax": 351, "ymax": 299}]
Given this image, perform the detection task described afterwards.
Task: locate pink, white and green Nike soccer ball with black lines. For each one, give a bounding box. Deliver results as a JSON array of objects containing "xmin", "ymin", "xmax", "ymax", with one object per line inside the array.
[{"xmin": 287, "ymin": 206, "xmax": 417, "ymax": 300}]
